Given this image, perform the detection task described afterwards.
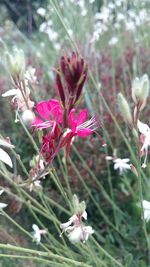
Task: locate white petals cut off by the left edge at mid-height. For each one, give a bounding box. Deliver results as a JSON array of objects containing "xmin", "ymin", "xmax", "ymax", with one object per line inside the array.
[{"xmin": 0, "ymin": 138, "xmax": 14, "ymax": 168}]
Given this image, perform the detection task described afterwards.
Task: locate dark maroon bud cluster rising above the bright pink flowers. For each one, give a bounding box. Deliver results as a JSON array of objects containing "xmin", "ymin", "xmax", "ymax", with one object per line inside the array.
[{"xmin": 56, "ymin": 52, "xmax": 87, "ymax": 110}]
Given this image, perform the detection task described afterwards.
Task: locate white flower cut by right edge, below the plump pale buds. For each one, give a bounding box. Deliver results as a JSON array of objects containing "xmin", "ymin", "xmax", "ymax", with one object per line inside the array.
[{"xmin": 137, "ymin": 120, "xmax": 150, "ymax": 168}]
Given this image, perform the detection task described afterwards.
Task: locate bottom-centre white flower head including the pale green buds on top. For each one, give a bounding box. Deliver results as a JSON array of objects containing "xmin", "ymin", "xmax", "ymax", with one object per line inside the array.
[{"xmin": 60, "ymin": 195, "xmax": 94, "ymax": 243}]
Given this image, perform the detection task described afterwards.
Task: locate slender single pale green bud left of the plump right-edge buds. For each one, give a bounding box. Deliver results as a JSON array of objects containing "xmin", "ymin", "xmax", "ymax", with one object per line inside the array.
[{"xmin": 118, "ymin": 93, "xmax": 133, "ymax": 126}]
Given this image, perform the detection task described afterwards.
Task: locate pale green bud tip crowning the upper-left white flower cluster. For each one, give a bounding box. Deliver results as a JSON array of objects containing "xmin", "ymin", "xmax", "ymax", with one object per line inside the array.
[{"xmin": 6, "ymin": 47, "xmax": 25, "ymax": 79}]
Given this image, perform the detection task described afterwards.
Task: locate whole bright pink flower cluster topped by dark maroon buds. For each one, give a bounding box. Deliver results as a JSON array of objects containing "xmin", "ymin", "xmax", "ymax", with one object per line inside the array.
[{"xmin": 32, "ymin": 52, "xmax": 104, "ymax": 163}]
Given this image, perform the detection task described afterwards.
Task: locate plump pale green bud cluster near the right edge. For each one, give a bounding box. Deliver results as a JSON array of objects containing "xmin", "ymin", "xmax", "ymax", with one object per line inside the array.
[{"xmin": 132, "ymin": 74, "xmax": 149, "ymax": 111}]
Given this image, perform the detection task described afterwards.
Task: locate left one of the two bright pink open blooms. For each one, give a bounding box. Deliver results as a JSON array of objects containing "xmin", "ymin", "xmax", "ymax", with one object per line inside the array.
[{"xmin": 32, "ymin": 99, "xmax": 63, "ymax": 129}]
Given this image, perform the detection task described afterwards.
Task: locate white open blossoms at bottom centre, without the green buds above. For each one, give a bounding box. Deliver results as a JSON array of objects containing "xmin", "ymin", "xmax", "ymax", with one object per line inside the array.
[{"xmin": 60, "ymin": 211, "xmax": 94, "ymax": 243}]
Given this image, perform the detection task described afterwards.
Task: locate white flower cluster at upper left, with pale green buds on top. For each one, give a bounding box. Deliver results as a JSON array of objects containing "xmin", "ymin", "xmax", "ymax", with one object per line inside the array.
[{"xmin": 2, "ymin": 48, "xmax": 36, "ymax": 123}]
